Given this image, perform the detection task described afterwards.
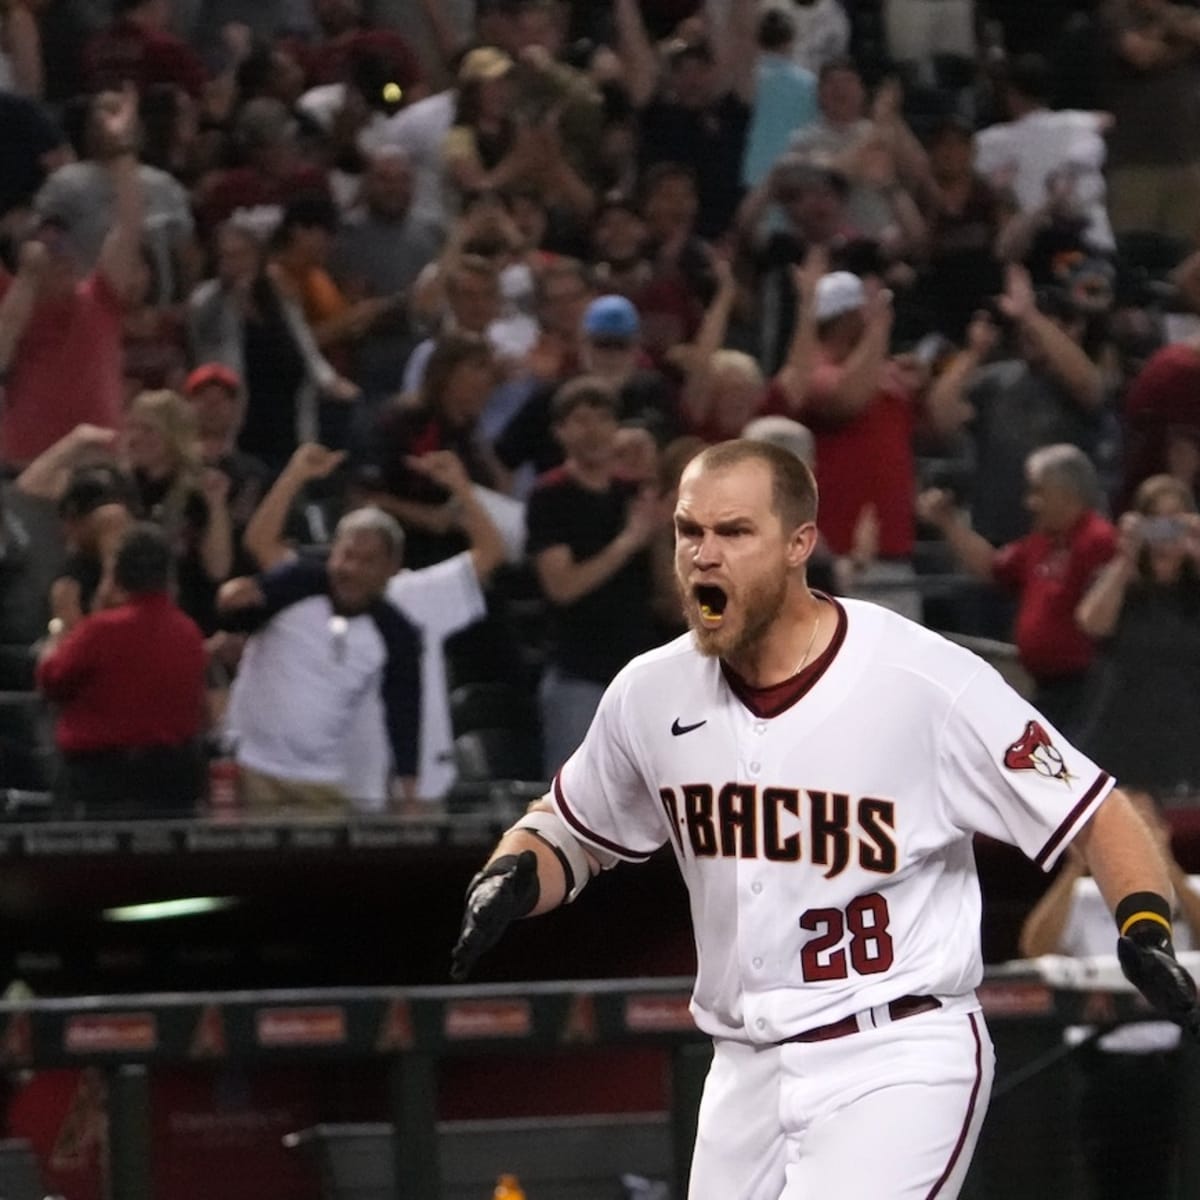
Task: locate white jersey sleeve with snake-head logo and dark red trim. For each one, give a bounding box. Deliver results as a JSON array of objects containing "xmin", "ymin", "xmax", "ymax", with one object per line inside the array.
[{"xmin": 938, "ymin": 666, "xmax": 1114, "ymax": 870}]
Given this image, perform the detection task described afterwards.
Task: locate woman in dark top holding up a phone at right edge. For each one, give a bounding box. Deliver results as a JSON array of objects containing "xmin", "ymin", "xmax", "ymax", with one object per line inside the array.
[{"xmin": 1075, "ymin": 475, "xmax": 1200, "ymax": 799}]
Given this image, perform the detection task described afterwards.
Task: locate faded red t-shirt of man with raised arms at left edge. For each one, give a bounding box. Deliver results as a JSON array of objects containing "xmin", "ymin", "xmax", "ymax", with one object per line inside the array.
[{"xmin": 0, "ymin": 271, "xmax": 124, "ymax": 463}]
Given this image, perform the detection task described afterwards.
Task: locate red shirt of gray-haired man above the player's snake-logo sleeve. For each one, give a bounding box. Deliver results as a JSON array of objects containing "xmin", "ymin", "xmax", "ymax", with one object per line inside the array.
[{"xmin": 994, "ymin": 512, "xmax": 1117, "ymax": 679}]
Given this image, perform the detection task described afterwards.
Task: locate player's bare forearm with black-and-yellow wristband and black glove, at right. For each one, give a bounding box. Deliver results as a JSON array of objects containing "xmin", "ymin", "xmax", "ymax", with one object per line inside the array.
[{"xmin": 1079, "ymin": 791, "xmax": 1200, "ymax": 1039}]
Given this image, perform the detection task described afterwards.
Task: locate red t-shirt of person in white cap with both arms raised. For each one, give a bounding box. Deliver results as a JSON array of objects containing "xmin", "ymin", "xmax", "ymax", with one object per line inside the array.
[{"xmin": 763, "ymin": 359, "xmax": 917, "ymax": 558}]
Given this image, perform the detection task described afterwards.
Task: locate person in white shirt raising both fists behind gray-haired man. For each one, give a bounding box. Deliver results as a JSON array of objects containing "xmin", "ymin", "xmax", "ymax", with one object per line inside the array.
[{"xmin": 245, "ymin": 444, "xmax": 506, "ymax": 812}]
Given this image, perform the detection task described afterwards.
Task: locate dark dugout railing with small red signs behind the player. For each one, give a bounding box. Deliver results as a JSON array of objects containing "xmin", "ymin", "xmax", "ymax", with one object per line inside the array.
[{"xmin": 0, "ymin": 960, "xmax": 1193, "ymax": 1200}]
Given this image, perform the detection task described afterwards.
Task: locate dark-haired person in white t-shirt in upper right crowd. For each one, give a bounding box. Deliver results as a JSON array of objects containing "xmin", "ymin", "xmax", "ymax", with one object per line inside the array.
[{"xmin": 976, "ymin": 54, "xmax": 1114, "ymax": 250}]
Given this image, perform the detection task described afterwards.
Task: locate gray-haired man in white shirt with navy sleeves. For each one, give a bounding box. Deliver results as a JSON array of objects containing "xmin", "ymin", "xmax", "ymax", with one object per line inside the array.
[{"xmin": 217, "ymin": 506, "xmax": 421, "ymax": 814}]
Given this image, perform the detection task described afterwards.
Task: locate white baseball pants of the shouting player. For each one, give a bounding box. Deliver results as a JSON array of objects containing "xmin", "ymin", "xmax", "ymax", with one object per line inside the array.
[{"xmin": 688, "ymin": 1009, "xmax": 995, "ymax": 1200}]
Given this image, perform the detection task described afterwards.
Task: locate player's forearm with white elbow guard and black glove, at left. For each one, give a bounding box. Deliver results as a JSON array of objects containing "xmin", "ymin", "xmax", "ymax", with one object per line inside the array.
[{"xmin": 450, "ymin": 800, "xmax": 600, "ymax": 983}]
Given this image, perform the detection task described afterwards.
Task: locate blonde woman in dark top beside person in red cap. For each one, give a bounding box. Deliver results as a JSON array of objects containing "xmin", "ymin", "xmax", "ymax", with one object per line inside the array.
[{"xmin": 124, "ymin": 390, "xmax": 234, "ymax": 632}]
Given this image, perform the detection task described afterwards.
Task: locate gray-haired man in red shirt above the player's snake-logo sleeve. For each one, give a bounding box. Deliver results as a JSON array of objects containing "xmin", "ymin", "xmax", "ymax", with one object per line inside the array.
[{"xmin": 918, "ymin": 443, "xmax": 1117, "ymax": 734}]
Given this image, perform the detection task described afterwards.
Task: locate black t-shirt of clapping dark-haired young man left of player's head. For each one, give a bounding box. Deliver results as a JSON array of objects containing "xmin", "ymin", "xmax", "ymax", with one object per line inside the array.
[{"xmin": 526, "ymin": 468, "xmax": 655, "ymax": 683}]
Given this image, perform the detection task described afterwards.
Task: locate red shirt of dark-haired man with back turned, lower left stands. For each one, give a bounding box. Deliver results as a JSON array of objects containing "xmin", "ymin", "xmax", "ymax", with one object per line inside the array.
[{"xmin": 37, "ymin": 592, "xmax": 206, "ymax": 754}]
